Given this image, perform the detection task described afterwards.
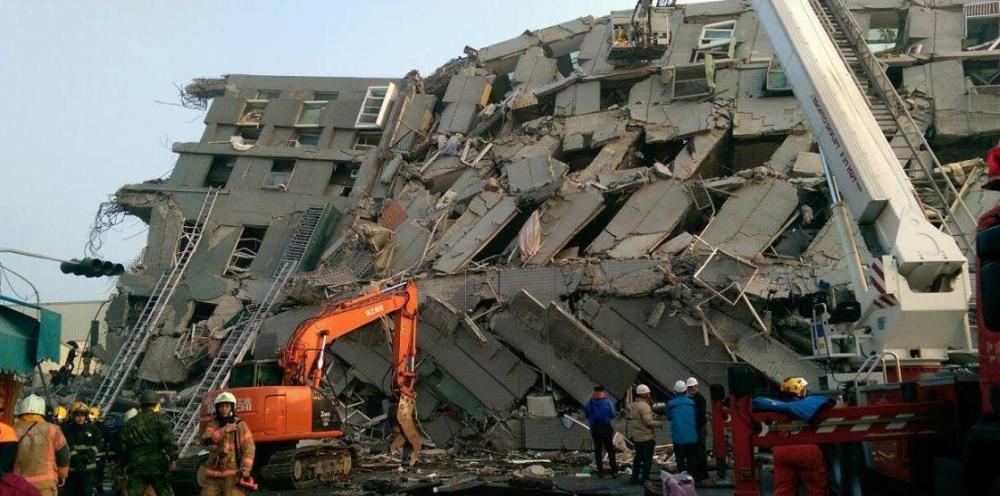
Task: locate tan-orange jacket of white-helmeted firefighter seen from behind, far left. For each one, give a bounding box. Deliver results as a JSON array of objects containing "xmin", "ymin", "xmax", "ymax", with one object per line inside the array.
[{"xmin": 14, "ymin": 419, "xmax": 69, "ymax": 489}]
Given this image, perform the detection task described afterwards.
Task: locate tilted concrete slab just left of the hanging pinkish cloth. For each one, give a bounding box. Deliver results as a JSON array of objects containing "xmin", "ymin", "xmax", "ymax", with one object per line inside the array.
[{"xmin": 434, "ymin": 191, "xmax": 519, "ymax": 274}]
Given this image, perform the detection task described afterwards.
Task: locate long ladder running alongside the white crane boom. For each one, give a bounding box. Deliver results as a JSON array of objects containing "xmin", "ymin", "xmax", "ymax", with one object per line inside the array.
[{"xmin": 809, "ymin": 0, "xmax": 976, "ymax": 257}]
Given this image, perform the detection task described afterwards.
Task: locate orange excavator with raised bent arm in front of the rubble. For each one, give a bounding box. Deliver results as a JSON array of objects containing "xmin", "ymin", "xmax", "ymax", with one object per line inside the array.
[{"xmin": 192, "ymin": 282, "xmax": 422, "ymax": 489}]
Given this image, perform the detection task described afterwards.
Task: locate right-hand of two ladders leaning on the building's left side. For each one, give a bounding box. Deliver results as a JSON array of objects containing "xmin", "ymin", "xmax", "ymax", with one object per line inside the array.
[{"xmin": 174, "ymin": 206, "xmax": 326, "ymax": 455}]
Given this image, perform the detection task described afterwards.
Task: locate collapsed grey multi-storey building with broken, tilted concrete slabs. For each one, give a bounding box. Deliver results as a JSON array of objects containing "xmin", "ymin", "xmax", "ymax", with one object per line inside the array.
[{"xmin": 90, "ymin": 0, "xmax": 1000, "ymax": 450}]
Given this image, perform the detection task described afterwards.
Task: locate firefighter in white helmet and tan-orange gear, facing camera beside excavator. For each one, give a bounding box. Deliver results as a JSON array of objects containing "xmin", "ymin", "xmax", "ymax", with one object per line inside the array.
[{"xmin": 201, "ymin": 391, "xmax": 255, "ymax": 496}]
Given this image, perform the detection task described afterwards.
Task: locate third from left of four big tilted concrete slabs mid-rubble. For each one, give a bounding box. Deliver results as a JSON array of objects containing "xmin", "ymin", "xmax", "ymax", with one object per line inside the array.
[{"xmin": 587, "ymin": 180, "xmax": 694, "ymax": 258}]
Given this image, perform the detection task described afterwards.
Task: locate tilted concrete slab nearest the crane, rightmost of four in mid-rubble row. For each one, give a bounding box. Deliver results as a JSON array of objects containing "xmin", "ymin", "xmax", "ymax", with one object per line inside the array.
[{"xmin": 701, "ymin": 178, "xmax": 798, "ymax": 259}]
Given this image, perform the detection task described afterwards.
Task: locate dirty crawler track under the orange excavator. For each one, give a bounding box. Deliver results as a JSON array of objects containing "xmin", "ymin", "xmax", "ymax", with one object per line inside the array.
[{"xmin": 260, "ymin": 446, "xmax": 355, "ymax": 489}]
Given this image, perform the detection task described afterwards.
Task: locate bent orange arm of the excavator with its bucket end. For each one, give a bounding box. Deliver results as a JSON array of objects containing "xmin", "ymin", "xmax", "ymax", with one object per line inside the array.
[{"xmin": 278, "ymin": 282, "xmax": 422, "ymax": 465}]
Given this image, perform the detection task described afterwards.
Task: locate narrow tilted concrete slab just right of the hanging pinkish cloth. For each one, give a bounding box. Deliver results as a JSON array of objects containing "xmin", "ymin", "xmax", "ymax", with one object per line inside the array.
[{"xmin": 528, "ymin": 185, "xmax": 604, "ymax": 265}]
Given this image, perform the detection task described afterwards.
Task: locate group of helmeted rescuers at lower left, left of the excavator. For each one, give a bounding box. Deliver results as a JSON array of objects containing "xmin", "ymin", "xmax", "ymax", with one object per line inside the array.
[{"xmin": 0, "ymin": 391, "xmax": 255, "ymax": 496}]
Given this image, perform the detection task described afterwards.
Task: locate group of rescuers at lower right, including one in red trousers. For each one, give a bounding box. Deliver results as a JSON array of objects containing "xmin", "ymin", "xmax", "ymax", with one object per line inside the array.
[{"xmin": 583, "ymin": 377, "xmax": 829, "ymax": 496}]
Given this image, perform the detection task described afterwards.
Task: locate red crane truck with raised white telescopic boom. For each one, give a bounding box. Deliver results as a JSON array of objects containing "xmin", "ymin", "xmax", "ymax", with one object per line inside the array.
[{"xmin": 712, "ymin": 0, "xmax": 1000, "ymax": 496}]
